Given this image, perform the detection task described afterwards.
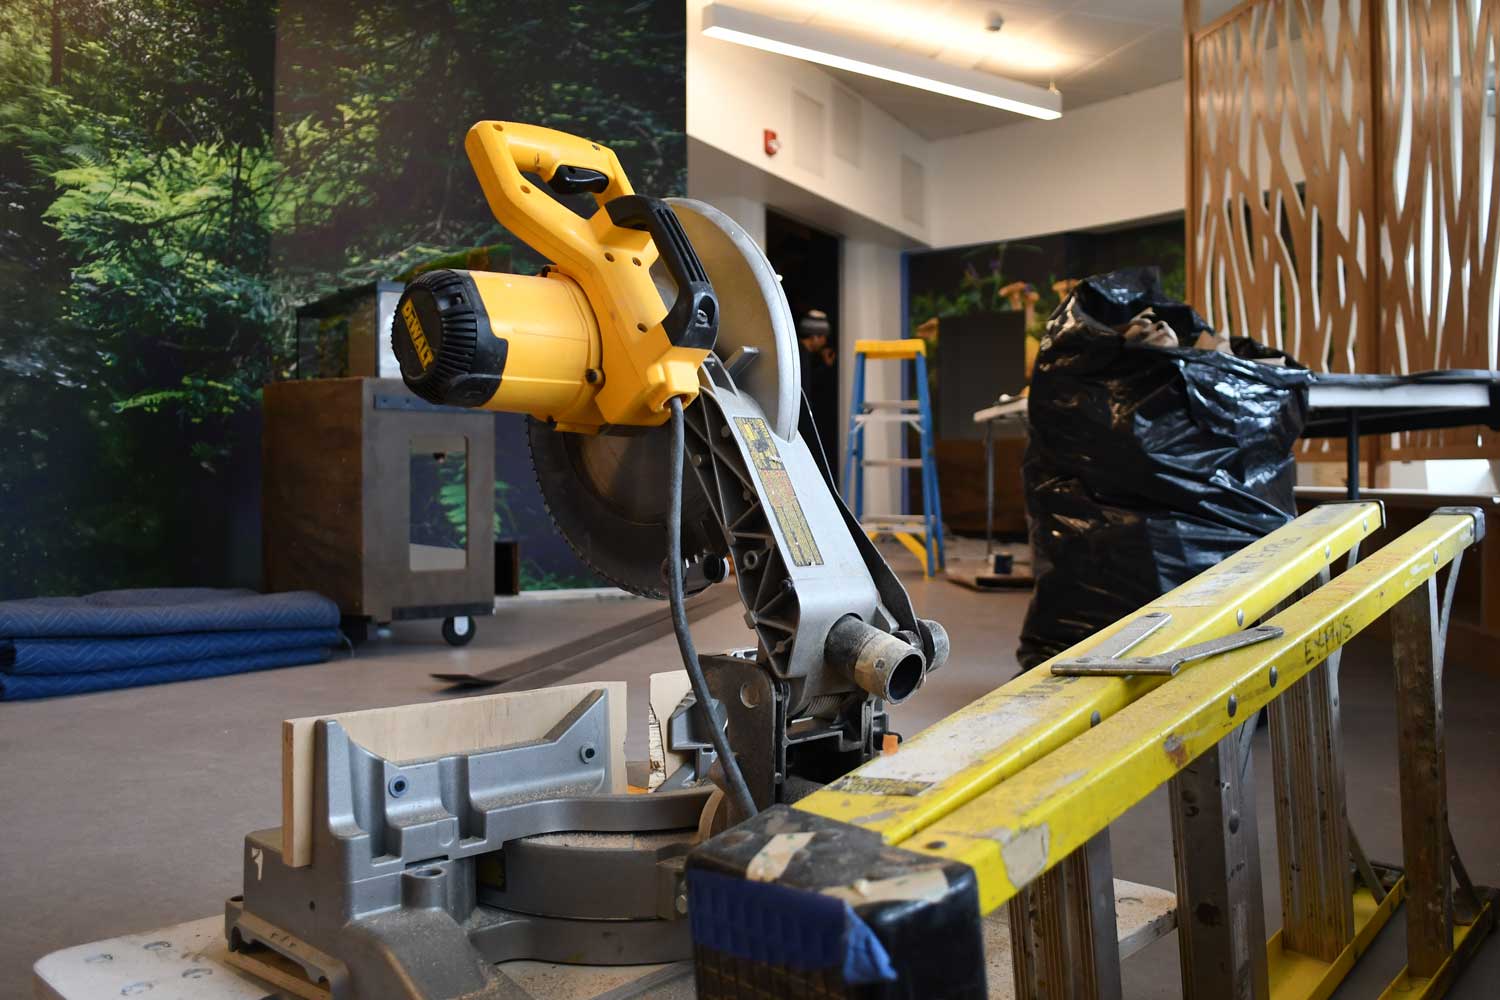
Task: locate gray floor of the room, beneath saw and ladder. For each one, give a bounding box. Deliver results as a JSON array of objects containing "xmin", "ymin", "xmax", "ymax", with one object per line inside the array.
[{"xmin": 0, "ymin": 556, "xmax": 1500, "ymax": 999}]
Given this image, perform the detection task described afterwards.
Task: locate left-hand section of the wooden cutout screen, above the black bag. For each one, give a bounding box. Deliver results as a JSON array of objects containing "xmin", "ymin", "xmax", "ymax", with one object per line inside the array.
[{"xmin": 1193, "ymin": 0, "xmax": 1374, "ymax": 372}]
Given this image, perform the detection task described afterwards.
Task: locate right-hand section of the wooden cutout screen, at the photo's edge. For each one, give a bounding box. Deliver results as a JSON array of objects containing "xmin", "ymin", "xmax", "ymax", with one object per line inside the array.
[{"xmin": 1376, "ymin": 0, "xmax": 1500, "ymax": 459}]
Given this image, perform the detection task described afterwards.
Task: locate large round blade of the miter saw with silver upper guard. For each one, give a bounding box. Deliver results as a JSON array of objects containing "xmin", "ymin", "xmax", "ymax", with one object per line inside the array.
[{"xmin": 527, "ymin": 198, "xmax": 801, "ymax": 598}]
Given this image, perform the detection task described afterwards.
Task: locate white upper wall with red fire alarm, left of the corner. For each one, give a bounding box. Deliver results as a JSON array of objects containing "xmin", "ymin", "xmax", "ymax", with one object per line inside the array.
[{"xmin": 687, "ymin": 0, "xmax": 933, "ymax": 244}]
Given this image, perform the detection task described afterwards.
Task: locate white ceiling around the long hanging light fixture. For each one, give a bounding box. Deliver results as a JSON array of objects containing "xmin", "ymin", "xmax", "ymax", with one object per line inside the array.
[{"xmin": 728, "ymin": 0, "xmax": 1236, "ymax": 139}]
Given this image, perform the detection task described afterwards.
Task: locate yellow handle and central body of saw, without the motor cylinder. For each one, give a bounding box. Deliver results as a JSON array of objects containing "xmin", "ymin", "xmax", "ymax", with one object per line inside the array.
[{"xmin": 464, "ymin": 121, "xmax": 717, "ymax": 429}]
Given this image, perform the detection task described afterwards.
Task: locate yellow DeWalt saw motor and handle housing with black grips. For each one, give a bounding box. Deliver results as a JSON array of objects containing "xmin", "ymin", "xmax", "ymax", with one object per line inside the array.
[{"xmin": 392, "ymin": 121, "xmax": 719, "ymax": 433}]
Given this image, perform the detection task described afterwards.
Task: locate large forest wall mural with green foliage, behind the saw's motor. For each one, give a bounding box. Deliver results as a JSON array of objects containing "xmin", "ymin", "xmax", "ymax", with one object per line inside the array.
[{"xmin": 0, "ymin": 0, "xmax": 686, "ymax": 598}]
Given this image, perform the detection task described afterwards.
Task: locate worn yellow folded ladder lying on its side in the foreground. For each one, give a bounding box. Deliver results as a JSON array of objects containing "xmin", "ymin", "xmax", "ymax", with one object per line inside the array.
[{"xmin": 690, "ymin": 502, "xmax": 1494, "ymax": 1000}]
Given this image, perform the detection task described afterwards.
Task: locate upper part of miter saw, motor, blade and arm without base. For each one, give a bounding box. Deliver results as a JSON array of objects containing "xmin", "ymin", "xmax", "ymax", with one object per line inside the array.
[{"xmin": 393, "ymin": 121, "xmax": 948, "ymax": 811}]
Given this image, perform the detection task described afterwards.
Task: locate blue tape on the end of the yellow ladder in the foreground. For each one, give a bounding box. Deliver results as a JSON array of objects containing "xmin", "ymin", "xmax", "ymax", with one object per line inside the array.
[{"xmin": 687, "ymin": 870, "xmax": 896, "ymax": 985}]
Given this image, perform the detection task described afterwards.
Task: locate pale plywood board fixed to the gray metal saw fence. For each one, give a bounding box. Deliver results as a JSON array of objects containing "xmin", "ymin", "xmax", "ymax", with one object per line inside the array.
[{"xmin": 282, "ymin": 681, "xmax": 626, "ymax": 868}]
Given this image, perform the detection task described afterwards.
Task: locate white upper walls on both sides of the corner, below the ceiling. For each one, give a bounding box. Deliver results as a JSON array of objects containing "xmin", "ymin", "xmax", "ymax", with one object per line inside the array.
[{"xmin": 687, "ymin": 18, "xmax": 1185, "ymax": 254}]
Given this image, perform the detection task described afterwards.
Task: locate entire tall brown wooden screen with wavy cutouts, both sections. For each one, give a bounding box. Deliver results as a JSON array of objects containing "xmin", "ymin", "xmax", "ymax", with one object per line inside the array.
[{"xmin": 1188, "ymin": 0, "xmax": 1500, "ymax": 459}]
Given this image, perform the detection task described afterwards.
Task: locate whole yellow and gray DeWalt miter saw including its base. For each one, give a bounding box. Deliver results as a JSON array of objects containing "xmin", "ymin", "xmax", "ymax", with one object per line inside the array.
[{"xmin": 219, "ymin": 121, "xmax": 948, "ymax": 999}]
